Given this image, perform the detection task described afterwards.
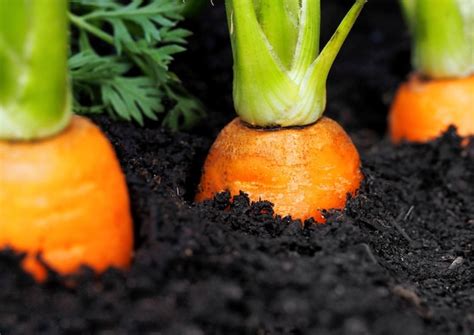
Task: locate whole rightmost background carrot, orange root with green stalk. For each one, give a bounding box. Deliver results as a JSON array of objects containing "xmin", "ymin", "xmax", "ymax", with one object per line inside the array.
[{"xmin": 389, "ymin": 0, "xmax": 474, "ymax": 142}]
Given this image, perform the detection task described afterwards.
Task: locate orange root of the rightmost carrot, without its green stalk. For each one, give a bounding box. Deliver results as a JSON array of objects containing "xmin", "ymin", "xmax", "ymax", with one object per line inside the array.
[{"xmin": 389, "ymin": 75, "xmax": 474, "ymax": 143}]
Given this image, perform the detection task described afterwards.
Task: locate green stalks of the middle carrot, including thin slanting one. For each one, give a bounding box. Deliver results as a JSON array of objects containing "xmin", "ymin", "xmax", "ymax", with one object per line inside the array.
[{"xmin": 226, "ymin": 0, "xmax": 366, "ymax": 127}]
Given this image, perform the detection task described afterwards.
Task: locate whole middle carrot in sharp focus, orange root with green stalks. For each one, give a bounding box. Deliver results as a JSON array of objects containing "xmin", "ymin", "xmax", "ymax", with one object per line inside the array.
[{"xmin": 196, "ymin": 0, "xmax": 365, "ymax": 222}]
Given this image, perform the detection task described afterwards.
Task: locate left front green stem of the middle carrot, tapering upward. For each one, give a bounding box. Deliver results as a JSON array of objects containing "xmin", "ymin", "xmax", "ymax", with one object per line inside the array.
[{"xmin": 226, "ymin": 0, "xmax": 298, "ymax": 125}]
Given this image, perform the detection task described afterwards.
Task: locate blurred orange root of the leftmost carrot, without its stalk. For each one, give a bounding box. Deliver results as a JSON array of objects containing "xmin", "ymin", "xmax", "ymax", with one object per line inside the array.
[{"xmin": 0, "ymin": 117, "xmax": 133, "ymax": 281}]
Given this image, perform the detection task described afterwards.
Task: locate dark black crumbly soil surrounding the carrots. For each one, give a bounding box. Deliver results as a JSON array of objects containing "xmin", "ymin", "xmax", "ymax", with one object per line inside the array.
[{"xmin": 0, "ymin": 0, "xmax": 474, "ymax": 335}]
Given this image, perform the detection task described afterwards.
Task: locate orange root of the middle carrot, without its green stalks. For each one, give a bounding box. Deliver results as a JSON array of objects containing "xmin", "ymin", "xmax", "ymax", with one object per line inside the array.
[{"xmin": 196, "ymin": 117, "xmax": 362, "ymax": 223}]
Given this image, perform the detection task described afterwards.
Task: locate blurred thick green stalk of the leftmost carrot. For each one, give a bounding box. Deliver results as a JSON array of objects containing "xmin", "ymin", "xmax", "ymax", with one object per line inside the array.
[{"xmin": 0, "ymin": 0, "xmax": 72, "ymax": 140}]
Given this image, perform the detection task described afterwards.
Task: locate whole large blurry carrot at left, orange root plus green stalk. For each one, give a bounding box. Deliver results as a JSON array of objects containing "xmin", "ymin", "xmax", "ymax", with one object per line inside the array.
[{"xmin": 0, "ymin": 0, "xmax": 133, "ymax": 280}]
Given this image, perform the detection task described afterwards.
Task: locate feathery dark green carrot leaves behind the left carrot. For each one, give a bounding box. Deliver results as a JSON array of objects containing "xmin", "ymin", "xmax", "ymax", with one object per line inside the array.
[{"xmin": 69, "ymin": 0, "xmax": 203, "ymax": 129}]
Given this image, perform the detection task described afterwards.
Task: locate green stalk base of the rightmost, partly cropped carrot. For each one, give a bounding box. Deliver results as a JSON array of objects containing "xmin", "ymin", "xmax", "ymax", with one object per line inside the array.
[{"xmin": 401, "ymin": 0, "xmax": 474, "ymax": 78}]
